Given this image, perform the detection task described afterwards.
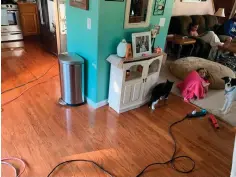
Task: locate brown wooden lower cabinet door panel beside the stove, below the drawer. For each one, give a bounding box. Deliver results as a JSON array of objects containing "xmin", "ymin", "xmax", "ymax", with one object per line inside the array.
[{"xmin": 21, "ymin": 13, "xmax": 38, "ymax": 36}]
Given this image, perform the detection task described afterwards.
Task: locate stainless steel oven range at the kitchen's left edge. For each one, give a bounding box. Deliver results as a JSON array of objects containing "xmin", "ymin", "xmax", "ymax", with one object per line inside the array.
[{"xmin": 1, "ymin": 4, "xmax": 23, "ymax": 42}]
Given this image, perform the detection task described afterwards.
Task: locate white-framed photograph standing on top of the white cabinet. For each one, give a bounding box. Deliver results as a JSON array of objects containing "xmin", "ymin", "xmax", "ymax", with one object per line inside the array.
[{"xmin": 132, "ymin": 31, "xmax": 152, "ymax": 58}]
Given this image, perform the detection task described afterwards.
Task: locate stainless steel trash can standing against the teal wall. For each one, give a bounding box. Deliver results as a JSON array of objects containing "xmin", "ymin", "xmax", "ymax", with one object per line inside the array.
[{"xmin": 59, "ymin": 53, "xmax": 84, "ymax": 106}]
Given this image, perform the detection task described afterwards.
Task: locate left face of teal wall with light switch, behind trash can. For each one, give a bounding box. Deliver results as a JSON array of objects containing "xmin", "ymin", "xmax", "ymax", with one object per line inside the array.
[{"xmin": 66, "ymin": 0, "xmax": 99, "ymax": 102}]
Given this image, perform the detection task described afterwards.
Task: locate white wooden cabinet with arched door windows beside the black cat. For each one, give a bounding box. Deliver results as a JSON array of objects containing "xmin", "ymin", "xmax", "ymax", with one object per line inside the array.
[{"xmin": 107, "ymin": 54, "xmax": 163, "ymax": 113}]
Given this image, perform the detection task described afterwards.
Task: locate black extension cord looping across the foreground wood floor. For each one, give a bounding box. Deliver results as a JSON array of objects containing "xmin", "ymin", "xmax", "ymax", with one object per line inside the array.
[{"xmin": 47, "ymin": 116, "xmax": 195, "ymax": 177}]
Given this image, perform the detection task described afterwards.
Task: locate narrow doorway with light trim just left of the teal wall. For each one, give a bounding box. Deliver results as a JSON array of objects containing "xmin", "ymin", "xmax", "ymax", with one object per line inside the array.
[{"xmin": 37, "ymin": 0, "xmax": 67, "ymax": 55}]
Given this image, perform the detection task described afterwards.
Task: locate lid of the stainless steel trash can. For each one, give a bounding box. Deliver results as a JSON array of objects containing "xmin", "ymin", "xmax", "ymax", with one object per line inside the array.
[{"xmin": 58, "ymin": 53, "xmax": 84, "ymax": 65}]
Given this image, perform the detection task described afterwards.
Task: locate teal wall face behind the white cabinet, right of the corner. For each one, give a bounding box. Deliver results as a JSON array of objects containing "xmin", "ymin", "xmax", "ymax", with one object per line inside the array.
[{"xmin": 97, "ymin": 0, "xmax": 173, "ymax": 102}]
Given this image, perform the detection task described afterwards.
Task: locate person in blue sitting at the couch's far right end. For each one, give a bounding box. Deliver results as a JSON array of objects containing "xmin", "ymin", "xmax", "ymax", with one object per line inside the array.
[{"xmin": 219, "ymin": 14, "xmax": 236, "ymax": 42}]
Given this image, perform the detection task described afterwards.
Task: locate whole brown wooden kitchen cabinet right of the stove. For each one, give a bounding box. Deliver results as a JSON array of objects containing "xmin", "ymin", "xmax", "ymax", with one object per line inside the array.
[{"xmin": 18, "ymin": 2, "xmax": 39, "ymax": 36}]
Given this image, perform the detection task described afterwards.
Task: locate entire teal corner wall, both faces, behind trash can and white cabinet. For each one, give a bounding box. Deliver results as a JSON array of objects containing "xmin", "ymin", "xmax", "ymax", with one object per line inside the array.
[{"xmin": 66, "ymin": 0, "xmax": 173, "ymax": 103}]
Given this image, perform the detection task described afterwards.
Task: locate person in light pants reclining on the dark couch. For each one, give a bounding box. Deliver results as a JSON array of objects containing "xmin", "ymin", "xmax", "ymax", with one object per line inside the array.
[{"xmin": 189, "ymin": 23, "xmax": 232, "ymax": 58}]
